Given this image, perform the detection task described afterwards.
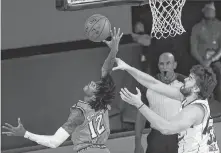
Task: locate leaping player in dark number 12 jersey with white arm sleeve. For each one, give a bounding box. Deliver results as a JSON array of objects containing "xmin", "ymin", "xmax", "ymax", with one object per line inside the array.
[{"xmin": 2, "ymin": 28, "xmax": 123, "ymax": 153}]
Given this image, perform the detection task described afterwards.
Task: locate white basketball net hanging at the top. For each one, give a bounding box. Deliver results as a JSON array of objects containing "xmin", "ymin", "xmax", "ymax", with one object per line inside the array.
[{"xmin": 149, "ymin": 0, "xmax": 186, "ymax": 39}]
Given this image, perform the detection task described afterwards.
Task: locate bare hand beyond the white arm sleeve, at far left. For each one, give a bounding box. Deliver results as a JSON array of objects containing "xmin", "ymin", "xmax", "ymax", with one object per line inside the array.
[{"xmin": 2, "ymin": 118, "xmax": 26, "ymax": 137}]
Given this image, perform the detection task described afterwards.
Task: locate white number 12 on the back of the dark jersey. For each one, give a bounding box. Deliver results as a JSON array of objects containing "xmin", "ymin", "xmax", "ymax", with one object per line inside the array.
[{"xmin": 89, "ymin": 114, "xmax": 105, "ymax": 139}]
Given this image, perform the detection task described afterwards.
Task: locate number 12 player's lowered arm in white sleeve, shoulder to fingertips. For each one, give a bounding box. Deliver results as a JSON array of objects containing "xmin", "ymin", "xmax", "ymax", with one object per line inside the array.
[{"xmin": 2, "ymin": 108, "xmax": 84, "ymax": 148}]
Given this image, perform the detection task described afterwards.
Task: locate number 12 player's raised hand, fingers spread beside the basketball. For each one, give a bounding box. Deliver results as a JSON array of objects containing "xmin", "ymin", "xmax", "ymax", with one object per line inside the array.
[{"xmin": 103, "ymin": 27, "xmax": 123, "ymax": 51}]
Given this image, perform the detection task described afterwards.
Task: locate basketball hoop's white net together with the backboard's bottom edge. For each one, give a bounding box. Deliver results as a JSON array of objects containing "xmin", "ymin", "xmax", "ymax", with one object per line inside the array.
[{"xmin": 56, "ymin": 0, "xmax": 186, "ymax": 39}]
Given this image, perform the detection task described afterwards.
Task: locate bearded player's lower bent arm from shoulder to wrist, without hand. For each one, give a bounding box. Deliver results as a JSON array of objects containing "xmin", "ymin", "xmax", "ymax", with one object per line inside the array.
[{"xmin": 139, "ymin": 104, "xmax": 205, "ymax": 135}]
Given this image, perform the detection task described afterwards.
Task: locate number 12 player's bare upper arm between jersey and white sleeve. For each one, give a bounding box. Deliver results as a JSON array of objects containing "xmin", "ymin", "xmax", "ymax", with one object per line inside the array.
[{"xmin": 62, "ymin": 108, "xmax": 85, "ymax": 134}]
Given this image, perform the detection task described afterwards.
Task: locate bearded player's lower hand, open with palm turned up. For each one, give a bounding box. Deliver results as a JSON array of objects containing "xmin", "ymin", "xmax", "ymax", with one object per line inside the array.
[{"xmin": 120, "ymin": 88, "xmax": 142, "ymax": 107}]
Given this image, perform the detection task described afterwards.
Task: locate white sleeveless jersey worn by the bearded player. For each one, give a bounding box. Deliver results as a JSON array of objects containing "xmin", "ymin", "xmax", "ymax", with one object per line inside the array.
[{"xmin": 178, "ymin": 100, "xmax": 219, "ymax": 153}]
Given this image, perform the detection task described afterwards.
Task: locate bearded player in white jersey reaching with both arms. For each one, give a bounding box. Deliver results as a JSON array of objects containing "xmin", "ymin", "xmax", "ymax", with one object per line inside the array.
[{"xmin": 113, "ymin": 59, "xmax": 219, "ymax": 153}]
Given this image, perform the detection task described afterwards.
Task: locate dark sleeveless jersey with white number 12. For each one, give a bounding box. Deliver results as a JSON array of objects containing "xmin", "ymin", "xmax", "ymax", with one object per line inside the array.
[{"xmin": 71, "ymin": 101, "xmax": 110, "ymax": 151}]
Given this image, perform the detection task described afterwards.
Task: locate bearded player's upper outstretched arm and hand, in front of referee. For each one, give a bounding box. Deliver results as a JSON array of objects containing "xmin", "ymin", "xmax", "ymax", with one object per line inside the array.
[{"xmin": 113, "ymin": 58, "xmax": 184, "ymax": 101}]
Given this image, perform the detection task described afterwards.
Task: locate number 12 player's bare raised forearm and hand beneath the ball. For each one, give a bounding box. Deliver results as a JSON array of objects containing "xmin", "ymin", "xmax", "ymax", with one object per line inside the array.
[{"xmin": 101, "ymin": 27, "xmax": 123, "ymax": 77}]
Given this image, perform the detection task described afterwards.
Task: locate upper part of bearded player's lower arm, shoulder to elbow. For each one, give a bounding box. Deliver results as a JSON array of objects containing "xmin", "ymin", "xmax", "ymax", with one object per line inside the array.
[{"xmin": 162, "ymin": 104, "xmax": 205, "ymax": 134}]
